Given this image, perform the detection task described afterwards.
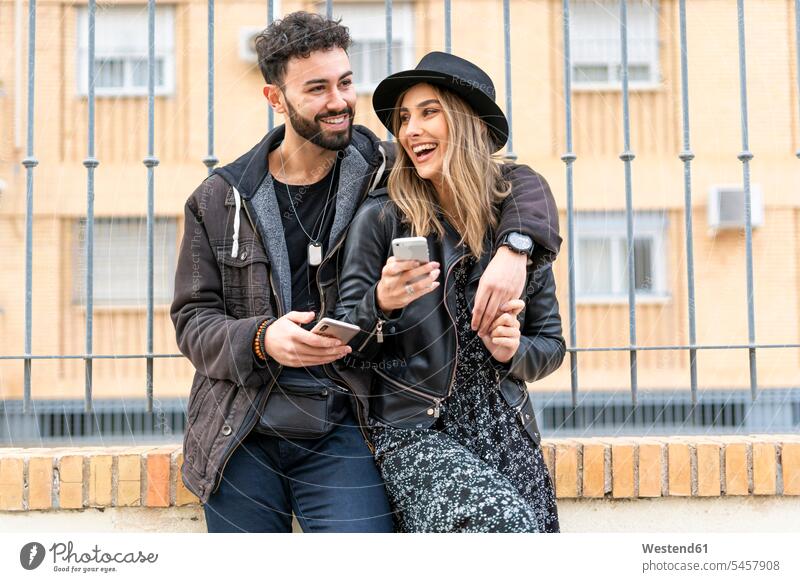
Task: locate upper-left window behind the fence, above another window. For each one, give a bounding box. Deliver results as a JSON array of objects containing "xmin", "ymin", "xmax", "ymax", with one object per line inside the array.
[{"xmin": 76, "ymin": 5, "xmax": 175, "ymax": 96}]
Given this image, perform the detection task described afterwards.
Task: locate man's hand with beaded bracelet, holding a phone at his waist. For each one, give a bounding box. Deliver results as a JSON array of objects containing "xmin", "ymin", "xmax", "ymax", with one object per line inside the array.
[{"xmin": 264, "ymin": 311, "xmax": 352, "ymax": 368}]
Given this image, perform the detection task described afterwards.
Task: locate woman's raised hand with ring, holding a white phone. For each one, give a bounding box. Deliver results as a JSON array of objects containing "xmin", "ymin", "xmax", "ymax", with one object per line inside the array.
[{"xmin": 376, "ymin": 257, "xmax": 441, "ymax": 313}]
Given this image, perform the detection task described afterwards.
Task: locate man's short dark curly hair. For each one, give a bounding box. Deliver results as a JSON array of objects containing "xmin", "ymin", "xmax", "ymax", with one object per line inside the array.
[{"xmin": 256, "ymin": 11, "xmax": 352, "ymax": 85}]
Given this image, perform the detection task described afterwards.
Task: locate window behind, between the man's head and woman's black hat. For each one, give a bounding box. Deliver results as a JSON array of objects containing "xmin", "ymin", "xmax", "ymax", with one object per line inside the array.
[{"xmin": 320, "ymin": 2, "xmax": 415, "ymax": 92}]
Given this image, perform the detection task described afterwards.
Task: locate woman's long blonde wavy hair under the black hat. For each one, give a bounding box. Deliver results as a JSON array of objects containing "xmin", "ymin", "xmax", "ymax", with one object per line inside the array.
[{"xmin": 388, "ymin": 85, "xmax": 511, "ymax": 258}]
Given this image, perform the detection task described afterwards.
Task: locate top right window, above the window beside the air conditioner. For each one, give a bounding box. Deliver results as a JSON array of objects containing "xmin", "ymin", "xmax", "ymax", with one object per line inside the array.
[{"xmin": 570, "ymin": 0, "xmax": 659, "ymax": 89}]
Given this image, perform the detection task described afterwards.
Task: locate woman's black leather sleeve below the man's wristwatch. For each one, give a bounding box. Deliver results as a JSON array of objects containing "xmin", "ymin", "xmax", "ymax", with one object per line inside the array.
[{"xmin": 509, "ymin": 264, "xmax": 566, "ymax": 382}]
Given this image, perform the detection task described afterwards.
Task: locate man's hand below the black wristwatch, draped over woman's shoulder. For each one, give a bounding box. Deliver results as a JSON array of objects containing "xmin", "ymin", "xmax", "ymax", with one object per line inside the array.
[{"xmin": 472, "ymin": 247, "xmax": 528, "ymax": 335}]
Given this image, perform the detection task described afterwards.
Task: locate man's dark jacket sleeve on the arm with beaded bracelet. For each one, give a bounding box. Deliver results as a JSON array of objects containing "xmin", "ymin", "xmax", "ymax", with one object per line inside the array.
[{"xmin": 170, "ymin": 177, "xmax": 279, "ymax": 387}]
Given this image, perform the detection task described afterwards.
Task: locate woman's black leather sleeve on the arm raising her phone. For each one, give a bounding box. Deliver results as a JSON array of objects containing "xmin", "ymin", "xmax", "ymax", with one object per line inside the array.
[{"xmin": 336, "ymin": 198, "xmax": 402, "ymax": 359}]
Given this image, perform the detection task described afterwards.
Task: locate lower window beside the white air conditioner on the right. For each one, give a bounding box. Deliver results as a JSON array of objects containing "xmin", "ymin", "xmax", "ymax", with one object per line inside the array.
[{"xmin": 575, "ymin": 212, "xmax": 667, "ymax": 301}]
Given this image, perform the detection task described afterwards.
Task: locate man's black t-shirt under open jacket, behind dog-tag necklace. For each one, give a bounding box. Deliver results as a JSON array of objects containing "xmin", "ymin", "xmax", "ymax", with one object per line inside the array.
[{"xmin": 273, "ymin": 163, "xmax": 339, "ymax": 386}]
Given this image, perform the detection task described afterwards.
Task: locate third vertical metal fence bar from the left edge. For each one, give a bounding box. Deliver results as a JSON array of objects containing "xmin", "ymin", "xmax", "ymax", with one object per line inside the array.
[{"xmin": 143, "ymin": 0, "xmax": 158, "ymax": 412}]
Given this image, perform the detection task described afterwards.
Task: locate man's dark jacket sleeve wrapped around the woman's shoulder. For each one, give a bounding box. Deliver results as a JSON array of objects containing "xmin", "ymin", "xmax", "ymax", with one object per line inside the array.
[{"xmin": 495, "ymin": 163, "xmax": 561, "ymax": 270}]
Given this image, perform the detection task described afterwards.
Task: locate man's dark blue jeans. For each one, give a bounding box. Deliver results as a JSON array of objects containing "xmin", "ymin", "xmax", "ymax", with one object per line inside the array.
[{"xmin": 203, "ymin": 413, "xmax": 394, "ymax": 533}]
